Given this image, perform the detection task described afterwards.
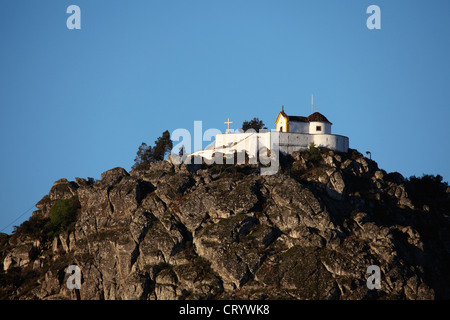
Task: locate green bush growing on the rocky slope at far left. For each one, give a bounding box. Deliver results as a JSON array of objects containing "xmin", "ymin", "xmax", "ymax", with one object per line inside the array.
[{"xmin": 44, "ymin": 197, "xmax": 80, "ymax": 237}]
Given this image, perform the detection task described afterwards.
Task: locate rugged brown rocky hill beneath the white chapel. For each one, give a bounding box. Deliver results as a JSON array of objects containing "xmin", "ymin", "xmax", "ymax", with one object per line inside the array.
[{"xmin": 0, "ymin": 150, "xmax": 450, "ymax": 299}]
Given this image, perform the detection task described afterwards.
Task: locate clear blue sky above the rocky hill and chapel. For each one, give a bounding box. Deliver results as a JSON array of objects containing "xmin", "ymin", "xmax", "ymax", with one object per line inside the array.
[{"xmin": 0, "ymin": 0, "xmax": 450, "ymax": 233}]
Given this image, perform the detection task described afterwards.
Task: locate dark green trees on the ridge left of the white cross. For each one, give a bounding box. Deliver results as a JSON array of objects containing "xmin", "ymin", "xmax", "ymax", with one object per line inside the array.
[{"xmin": 132, "ymin": 130, "xmax": 173, "ymax": 170}]
